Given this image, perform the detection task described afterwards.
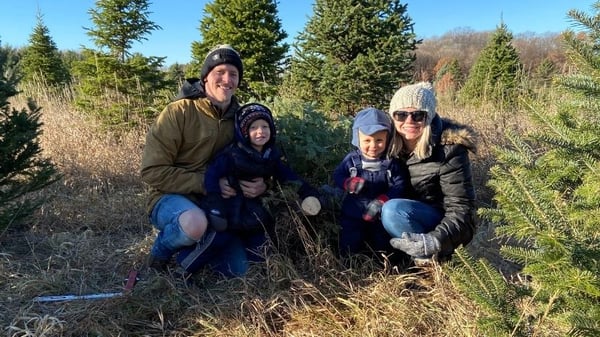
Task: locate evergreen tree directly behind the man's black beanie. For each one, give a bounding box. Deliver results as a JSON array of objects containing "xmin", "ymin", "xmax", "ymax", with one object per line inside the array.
[{"xmin": 190, "ymin": 0, "xmax": 289, "ymax": 100}]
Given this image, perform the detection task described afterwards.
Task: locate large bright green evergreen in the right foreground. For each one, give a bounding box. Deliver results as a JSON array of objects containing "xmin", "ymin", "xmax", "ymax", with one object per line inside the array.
[{"xmin": 450, "ymin": 2, "xmax": 600, "ymax": 336}]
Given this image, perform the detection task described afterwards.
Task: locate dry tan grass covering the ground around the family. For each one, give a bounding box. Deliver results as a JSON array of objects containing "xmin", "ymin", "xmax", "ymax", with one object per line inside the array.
[{"xmin": 0, "ymin": 82, "xmax": 536, "ymax": 337}]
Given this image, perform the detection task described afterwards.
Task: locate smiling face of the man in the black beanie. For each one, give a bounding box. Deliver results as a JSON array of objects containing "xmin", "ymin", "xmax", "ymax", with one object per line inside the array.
[{"xmin": 204, "ymin": 64, "xmax": 240, "ymax": 109}]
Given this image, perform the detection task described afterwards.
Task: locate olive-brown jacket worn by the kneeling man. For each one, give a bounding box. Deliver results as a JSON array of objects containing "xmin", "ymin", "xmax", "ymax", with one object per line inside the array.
[{"xmin": 141, "ymin": 97, "xmax": 239, "ymax": 214}]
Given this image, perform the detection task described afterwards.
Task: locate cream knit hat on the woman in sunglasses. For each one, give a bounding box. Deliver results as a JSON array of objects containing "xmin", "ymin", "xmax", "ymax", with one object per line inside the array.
[{"xmin": 389, "ymin": 82, "xmax": 436, "ymax": 124}]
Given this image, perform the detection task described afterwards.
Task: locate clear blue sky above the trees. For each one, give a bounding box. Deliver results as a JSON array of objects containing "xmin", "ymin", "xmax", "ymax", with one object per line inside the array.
[{"xmin": 0, "ymin": 0, "xmax": 594, "ymax": 65}]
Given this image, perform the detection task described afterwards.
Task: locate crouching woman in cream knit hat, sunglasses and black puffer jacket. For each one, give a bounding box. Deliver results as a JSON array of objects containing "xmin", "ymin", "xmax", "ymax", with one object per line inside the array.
[{"xmin": 381, "ymin": 82, "xmax": 476, "ymax": 265}]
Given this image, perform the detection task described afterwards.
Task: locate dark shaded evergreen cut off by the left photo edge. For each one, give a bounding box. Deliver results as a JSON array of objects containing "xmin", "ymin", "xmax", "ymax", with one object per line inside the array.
[{"xmin": 0, "ymin": 40, "xmax": 60, "ymax": 231}]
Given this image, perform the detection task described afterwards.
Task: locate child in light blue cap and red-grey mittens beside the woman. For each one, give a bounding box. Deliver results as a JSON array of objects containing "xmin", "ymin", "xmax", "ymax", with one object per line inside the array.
[{"xmin": 333, "ymin": 108, "xmax": 408, "ymax": 256}]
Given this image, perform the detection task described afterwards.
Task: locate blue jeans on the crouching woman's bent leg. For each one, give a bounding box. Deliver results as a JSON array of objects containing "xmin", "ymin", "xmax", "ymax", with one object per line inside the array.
[{"xmin": 381, "ymin": 199, "xmax": 444, "ymax": 238}]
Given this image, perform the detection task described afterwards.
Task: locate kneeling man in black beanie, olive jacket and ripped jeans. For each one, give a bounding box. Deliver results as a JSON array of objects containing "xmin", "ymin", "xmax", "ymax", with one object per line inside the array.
[{"xmin": 141, "ymin": 45, "xmax": 266, "ymax": 276}]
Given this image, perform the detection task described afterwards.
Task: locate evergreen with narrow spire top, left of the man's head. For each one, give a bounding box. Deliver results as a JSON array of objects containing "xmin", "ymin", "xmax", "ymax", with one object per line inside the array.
[{"xmin": 73, "ymin": 0, "xmax": 169, "ymax": 126}]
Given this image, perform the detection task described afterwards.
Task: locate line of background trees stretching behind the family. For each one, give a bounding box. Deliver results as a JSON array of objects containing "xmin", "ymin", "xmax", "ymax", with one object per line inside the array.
[{"xmin": 1, "ymin": 0, "xmax": 565, "ymax": 123}]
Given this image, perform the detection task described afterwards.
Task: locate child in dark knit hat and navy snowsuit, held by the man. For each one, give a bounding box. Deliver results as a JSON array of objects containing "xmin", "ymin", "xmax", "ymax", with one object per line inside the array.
[{"xmin": 178, "ymin": 103, "xmax": 321, "ymax": 276}]
